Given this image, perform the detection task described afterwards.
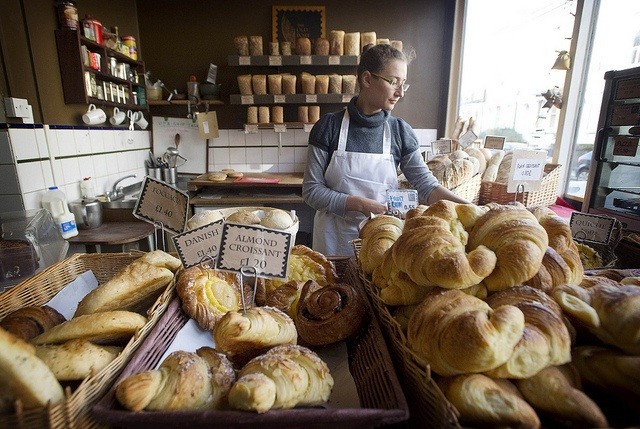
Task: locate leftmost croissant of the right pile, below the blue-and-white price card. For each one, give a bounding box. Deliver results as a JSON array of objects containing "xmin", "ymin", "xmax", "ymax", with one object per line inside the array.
[{"xmin": 358, "ymin": 215, "xmax": 404, "ymax": 274}]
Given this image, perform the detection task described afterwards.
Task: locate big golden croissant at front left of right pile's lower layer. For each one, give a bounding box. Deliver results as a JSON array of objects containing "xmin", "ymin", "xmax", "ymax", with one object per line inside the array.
[{"xmin": 407, "ymin": 288, "xmax": 525, "ymax": 376}]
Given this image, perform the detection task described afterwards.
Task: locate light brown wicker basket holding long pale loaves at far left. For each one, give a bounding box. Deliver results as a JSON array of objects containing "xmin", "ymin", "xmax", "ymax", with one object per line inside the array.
[{"xmin": 0, "ymin": 251, "xmax": 175, "ymax": 429}]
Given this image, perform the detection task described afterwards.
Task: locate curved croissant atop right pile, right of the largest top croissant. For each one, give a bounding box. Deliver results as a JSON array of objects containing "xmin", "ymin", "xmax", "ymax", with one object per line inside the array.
[{"xmin": 468, "ymin": 203, "xmax": 549, "ymax": 292}]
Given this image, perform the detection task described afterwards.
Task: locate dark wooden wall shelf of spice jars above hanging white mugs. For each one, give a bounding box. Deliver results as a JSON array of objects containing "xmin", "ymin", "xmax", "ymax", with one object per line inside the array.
[{"xmin": 55, "ymin": 30, "xmax": 148, "ymax": 110}]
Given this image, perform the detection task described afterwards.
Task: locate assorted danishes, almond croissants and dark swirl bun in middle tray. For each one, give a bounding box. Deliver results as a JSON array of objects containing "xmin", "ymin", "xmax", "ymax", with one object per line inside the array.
[{"xmin": 115, "ymin": 245, "xmax": 367, "ymax": 413}]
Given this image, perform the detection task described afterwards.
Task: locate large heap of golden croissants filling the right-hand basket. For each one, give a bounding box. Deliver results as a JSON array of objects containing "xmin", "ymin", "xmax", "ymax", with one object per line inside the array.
[{"xmin": 358, "ymin": 201, "xmax": 640, "ymax": 428}]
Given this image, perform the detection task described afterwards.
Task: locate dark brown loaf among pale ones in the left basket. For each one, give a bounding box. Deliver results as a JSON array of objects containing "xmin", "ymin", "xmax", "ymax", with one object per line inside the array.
[{"xmin": 0, "ymin": 305, "xmax": 67, "ymax": 341}]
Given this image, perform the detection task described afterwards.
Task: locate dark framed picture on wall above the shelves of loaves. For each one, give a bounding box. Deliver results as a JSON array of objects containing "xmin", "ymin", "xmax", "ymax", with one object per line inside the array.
[{"xmin": 271, "ymin": 6, "xmax": 326, "ymax": 43}]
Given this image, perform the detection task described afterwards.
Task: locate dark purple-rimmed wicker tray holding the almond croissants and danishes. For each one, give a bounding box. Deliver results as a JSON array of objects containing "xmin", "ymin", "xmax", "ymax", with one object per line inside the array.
[{"xmin": 93, "ymin": 258, "xmax": 409, "ymax": 429}]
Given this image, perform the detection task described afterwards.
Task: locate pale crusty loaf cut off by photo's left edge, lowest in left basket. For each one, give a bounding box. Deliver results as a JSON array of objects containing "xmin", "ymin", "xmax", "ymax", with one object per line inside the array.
[{"xmin": 0, "ymin": 328, "xmax": 64, "ymax": 411}]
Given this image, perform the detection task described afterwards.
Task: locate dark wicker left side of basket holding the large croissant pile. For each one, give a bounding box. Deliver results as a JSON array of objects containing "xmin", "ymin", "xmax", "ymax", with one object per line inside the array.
[{"xmin": 353, "ymin": 239, "xmax": 461, "ymax": 428}]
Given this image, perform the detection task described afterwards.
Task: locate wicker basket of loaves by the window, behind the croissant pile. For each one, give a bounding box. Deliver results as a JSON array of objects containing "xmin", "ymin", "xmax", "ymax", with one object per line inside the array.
[{"xmin": 478, "ymin": 164, "xmax": 562, "ymax": 207}]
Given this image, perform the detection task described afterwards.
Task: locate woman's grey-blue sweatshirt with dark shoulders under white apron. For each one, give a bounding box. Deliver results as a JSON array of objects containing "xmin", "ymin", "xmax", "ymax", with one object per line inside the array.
[{"xmin": 302, "ymin": 97, "xmax": 438, "ymax": 216}]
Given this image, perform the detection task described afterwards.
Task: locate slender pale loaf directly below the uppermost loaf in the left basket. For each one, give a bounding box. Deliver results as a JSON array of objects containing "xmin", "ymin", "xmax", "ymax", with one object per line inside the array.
[{"xmin": 31, "ymin": 310, "xmax": 147, "ymax": 344}]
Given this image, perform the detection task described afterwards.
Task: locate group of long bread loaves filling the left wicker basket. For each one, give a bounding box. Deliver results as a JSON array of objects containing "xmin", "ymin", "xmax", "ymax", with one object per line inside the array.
[{"xmin": 0, "ymin": 250, "xmax": 182, "ymax": 412}]
